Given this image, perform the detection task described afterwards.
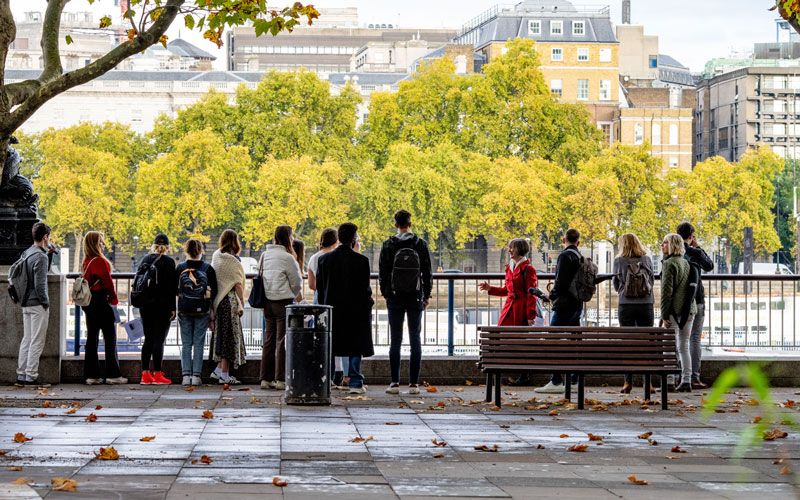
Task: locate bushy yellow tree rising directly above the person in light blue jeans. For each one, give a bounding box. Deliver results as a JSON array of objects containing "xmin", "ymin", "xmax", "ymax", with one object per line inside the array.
[{"xmin": 133, "ymin": 130, "xmax": 253, "ymax": 246}]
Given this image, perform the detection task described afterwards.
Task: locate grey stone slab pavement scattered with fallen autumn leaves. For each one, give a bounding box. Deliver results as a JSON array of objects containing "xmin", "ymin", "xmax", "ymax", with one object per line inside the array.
[{"xmin": 0, "ymin": 385, "xmax": 800, "ymax": 500}]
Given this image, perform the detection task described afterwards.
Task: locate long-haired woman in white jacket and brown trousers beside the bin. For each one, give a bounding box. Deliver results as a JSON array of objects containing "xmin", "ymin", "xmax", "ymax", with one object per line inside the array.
[{"xmin": 258, "ymin": 226, "xmax": 303, "ymax": 391}]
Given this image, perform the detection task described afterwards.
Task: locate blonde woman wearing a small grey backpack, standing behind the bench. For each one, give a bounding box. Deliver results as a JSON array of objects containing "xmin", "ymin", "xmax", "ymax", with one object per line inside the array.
[{"xmin": 612, "ymin": 233, "xmax": 654, "ymax": 394}]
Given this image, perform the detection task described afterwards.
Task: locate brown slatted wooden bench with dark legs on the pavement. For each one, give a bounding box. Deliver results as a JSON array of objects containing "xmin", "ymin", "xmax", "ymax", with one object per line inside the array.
[{"xmin": 478, "ymin": 326, "xmax": 680, "ymax": 410}]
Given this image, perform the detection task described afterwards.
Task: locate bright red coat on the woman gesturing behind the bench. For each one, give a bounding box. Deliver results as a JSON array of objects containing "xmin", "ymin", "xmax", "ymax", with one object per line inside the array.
[{"xmin": 489, "ymin": 260, "xmax": 539, "ymax": 326}]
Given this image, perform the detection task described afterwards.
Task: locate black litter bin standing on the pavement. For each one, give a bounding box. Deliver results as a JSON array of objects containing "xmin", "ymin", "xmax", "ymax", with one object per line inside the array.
[{"xmin": 285, "ymin": 304, "xmax": 333, "ymax": 405}]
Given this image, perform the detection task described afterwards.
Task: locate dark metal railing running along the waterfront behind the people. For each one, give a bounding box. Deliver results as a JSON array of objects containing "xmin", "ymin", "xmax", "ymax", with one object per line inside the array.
[{"xmin": 65, "ymin": 273, "xmax": 800, "ymax": 356}]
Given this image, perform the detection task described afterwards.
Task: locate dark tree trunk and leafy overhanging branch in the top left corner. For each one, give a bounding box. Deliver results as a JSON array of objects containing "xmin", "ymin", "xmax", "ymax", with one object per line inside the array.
[{"xmin": 0, "ymin": 0, "xmax": 319, "ymax": 177}]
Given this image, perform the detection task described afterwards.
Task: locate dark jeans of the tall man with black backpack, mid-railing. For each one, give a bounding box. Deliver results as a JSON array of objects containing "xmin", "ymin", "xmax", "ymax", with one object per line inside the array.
[{"xmin": 386, "ymin": 300, "xmax": 424, "ymax": 384}]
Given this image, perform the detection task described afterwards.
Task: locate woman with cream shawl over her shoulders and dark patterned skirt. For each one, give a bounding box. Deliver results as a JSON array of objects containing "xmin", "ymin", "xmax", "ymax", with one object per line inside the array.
[{"xmin": 211, "ymin": 229, "xmax": 247, "ymax": 385}]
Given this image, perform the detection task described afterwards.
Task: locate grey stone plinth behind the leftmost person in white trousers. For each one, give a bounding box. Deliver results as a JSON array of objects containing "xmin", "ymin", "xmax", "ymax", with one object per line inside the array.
[{"xmin": 0, "ymin": 269, "xmax": 67, "ymax": 384}]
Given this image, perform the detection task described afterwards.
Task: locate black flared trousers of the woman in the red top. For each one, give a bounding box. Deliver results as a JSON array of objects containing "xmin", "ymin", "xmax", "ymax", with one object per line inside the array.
[{"xmin": 83, "ymin": 290, "xmax": 121, "ymax": 379}]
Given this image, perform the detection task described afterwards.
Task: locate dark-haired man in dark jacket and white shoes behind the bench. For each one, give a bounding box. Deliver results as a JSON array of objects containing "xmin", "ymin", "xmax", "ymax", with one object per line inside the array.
[{"xmin": 535, "ymin": 229, "xmax": 583, "ymax": 394}]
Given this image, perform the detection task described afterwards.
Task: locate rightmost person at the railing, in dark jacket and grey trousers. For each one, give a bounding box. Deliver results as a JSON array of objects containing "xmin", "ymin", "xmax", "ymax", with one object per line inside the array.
[{"xmin": 675, "ymin": 222, "xmax": 712, "ymax": 389}]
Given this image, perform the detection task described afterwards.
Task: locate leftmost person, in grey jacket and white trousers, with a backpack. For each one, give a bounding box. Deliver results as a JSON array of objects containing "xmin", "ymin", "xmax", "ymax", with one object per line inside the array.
[{"xmin": 14, "ymin": 222, "xmax": 55, "ymax": 387}]
